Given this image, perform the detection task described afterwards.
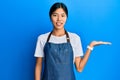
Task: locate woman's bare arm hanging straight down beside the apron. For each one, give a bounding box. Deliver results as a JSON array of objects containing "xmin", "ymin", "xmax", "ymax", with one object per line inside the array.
[{"xmin": 35, "ymin": 57, "xmax": 42, "ymax": 80}]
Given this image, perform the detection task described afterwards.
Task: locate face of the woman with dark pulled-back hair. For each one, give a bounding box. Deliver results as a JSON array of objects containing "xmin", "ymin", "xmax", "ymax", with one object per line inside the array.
[{"xmin": 51, "ymin": 8, "xmax": 67, "ymax": 30}]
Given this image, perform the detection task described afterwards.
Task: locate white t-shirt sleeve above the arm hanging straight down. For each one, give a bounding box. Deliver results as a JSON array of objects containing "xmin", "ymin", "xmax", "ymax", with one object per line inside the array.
[{"xmin": 34, "ymin": 36, "xmax": 44, "ymax": 57}]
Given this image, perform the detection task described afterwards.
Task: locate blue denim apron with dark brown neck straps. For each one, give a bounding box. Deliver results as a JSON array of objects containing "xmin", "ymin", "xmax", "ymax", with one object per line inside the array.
[{"xmin": 42, "ymin": 31, "xmax": 75, "ymax": 80}]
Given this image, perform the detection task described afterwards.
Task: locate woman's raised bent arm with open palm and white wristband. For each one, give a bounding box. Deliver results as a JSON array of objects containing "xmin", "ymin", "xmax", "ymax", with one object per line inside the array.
[{"xmin": 75, "ymin": 41, "xmax": 111, "ymax": 72}]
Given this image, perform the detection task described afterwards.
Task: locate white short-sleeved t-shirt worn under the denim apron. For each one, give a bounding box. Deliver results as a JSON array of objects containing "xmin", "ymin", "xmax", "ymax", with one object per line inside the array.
[{"xmin": 34, "ymin": 32, "xmax": 83, "ymax": 59}]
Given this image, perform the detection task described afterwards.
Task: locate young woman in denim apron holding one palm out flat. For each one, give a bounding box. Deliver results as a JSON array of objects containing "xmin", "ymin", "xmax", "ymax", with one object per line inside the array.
[{"xmin": 35, "ymin": 3, "xmax": 110, "ymax": 80}]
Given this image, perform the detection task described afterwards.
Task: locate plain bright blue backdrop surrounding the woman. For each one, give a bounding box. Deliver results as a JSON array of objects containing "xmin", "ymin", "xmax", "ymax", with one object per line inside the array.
[{"xmin": 0, "ymin": 0, "xmax": 120, "ymax": 80}]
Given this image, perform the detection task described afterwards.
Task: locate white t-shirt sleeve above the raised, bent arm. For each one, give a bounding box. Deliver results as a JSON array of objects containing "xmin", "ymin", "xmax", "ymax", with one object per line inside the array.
[{"xmin": 74, "ymin": 35, "xmax": 83, "ymax": 57}]
